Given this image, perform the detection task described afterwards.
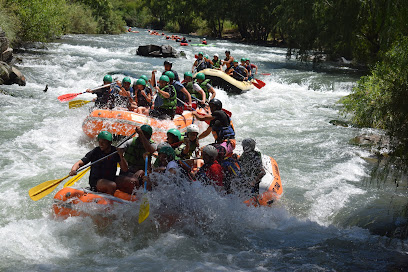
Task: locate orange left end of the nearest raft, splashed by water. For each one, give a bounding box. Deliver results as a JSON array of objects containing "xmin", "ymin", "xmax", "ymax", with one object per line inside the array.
[{"xmin": 52, "ymin": 187, "xmax": 138, "ymax": 218}]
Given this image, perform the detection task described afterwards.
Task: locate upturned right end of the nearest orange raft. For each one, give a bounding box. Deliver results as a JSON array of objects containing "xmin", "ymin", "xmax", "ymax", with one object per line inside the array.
[{"xmin": 244, "ymin": 155, "xmax": 283, "ymax": 207}]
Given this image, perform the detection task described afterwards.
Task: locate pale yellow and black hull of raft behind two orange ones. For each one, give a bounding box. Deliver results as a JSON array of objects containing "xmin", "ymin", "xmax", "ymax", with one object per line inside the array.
[{"xmin": 196, "ymin": 69, "xmax": 255, "ymax": 94}]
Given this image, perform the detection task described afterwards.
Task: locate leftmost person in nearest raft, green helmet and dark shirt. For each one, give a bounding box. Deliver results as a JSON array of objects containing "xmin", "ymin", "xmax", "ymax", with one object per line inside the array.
[{"xmin": 69, "ymin": 131, "xmax": 128, "ymax": 195}]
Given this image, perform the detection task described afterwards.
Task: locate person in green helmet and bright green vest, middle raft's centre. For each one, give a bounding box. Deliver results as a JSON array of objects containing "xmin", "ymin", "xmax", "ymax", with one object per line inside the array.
[{"xmin": 149, "ymin": 75, "xmax": 177, "ymax": 119}]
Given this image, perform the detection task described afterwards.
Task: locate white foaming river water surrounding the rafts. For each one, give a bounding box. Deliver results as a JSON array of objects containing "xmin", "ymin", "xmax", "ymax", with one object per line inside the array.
[{"xmin": 0, "ymin": 30, "xmax": 408, "ymax": 271}]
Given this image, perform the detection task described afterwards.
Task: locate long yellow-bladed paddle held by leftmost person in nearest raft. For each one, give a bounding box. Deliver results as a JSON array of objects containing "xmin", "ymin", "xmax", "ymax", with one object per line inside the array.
[{"xmin": 28, "ymin": 131, "xmax": 136, "ymax": 201}]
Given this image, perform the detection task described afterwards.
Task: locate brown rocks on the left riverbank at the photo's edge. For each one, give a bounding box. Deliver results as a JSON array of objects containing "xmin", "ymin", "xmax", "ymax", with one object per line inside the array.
[{"xmin": 0, "ymin": 27, "xmax": 26, "ymax": 86}]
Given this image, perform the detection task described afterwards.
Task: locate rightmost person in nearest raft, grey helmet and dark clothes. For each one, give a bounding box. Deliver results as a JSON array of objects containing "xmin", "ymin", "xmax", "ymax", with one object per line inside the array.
[{"xmin": 238, "ymin": 138, "xmax": 266, "ymax": 195}]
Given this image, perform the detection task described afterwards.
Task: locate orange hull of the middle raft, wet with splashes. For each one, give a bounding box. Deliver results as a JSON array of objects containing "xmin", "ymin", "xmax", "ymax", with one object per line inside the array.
[{"xmin": 82, "ymin": 109, "xmax": 206, "ymax": 142}]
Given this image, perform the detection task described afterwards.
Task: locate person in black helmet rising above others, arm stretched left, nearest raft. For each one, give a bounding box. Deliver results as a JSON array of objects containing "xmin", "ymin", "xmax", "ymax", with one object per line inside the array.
[{"xmin": 192, "ymin": 98, "xmax": 236, "ymax": 156}]
